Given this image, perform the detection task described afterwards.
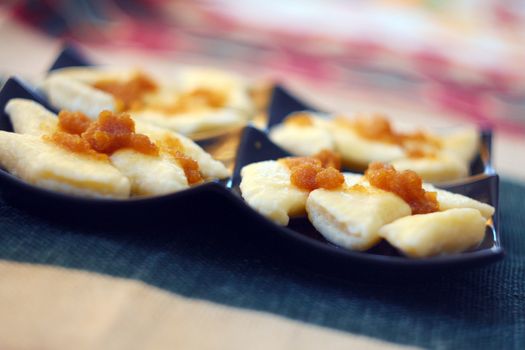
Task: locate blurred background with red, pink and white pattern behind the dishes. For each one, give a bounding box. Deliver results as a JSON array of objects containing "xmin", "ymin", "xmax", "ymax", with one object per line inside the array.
[{"xmin": 0, "ymin": 0, "xmax": 525, "ymax": 179}]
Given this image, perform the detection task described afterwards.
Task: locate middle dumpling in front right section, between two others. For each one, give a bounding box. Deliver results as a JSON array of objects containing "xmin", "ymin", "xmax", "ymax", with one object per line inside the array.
[{"xmin": 306, "ymin": 185, "xmax": 411, "ymax": 250}]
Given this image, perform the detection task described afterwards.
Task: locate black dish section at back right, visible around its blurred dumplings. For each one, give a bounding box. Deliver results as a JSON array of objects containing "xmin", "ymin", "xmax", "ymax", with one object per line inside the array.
[{"xmin": 266, "ymin": 86, "xmax": 496, "ymax": 184}]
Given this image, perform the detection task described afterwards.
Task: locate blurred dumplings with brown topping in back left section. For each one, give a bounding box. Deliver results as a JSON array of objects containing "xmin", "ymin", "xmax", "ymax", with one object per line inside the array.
[{"xmin": 42, "ymin": 67, "xmax": 254, "ymax": 135}]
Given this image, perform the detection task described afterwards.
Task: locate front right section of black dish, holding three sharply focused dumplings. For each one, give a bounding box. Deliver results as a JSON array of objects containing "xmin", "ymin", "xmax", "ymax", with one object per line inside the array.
[{"xmin": 229, "ymin": 127, "xmax": 503, "ymax": 269}]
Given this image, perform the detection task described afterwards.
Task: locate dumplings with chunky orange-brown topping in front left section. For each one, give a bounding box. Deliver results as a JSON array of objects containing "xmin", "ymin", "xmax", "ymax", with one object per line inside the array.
[{"xmin": 0, "ymin": 99, "xmax": 229, "ymax": 198}]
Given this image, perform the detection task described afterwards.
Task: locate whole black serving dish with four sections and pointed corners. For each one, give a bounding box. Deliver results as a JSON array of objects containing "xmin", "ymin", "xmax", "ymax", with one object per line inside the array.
[{"xmin": 0, "ymin": 48, "xmax": 503, "ymax": 271}]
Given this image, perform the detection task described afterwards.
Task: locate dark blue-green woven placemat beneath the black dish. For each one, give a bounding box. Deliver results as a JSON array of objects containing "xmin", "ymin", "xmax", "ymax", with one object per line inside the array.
[{"xmin": 0, "ymin": 181, "xmax": 525, "ymax": 349}]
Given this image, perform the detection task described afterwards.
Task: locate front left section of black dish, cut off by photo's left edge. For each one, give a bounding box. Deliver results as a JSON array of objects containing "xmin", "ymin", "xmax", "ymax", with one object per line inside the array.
[{"xmin": 0, "ymin": 77, "xmax": 230, "ymax": 217}]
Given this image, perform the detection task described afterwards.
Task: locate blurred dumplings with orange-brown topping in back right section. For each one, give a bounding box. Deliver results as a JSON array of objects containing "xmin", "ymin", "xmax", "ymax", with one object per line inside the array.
[{"xmin": 270, "ymin": 112, "xmax": 479, "ymax": 183}]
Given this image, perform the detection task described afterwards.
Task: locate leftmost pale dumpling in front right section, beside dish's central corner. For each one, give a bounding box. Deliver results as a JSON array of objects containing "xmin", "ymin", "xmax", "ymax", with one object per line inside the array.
[{"xmin": 240, "ymin": 160, "xmax": 308, "ymax": 226}]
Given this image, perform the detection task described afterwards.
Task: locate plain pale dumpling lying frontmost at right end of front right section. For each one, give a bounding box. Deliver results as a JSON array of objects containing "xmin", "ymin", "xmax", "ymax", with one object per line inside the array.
[{"xmin": 379, "ymin": 208, "xmax": 486, "ymax": 258}]
